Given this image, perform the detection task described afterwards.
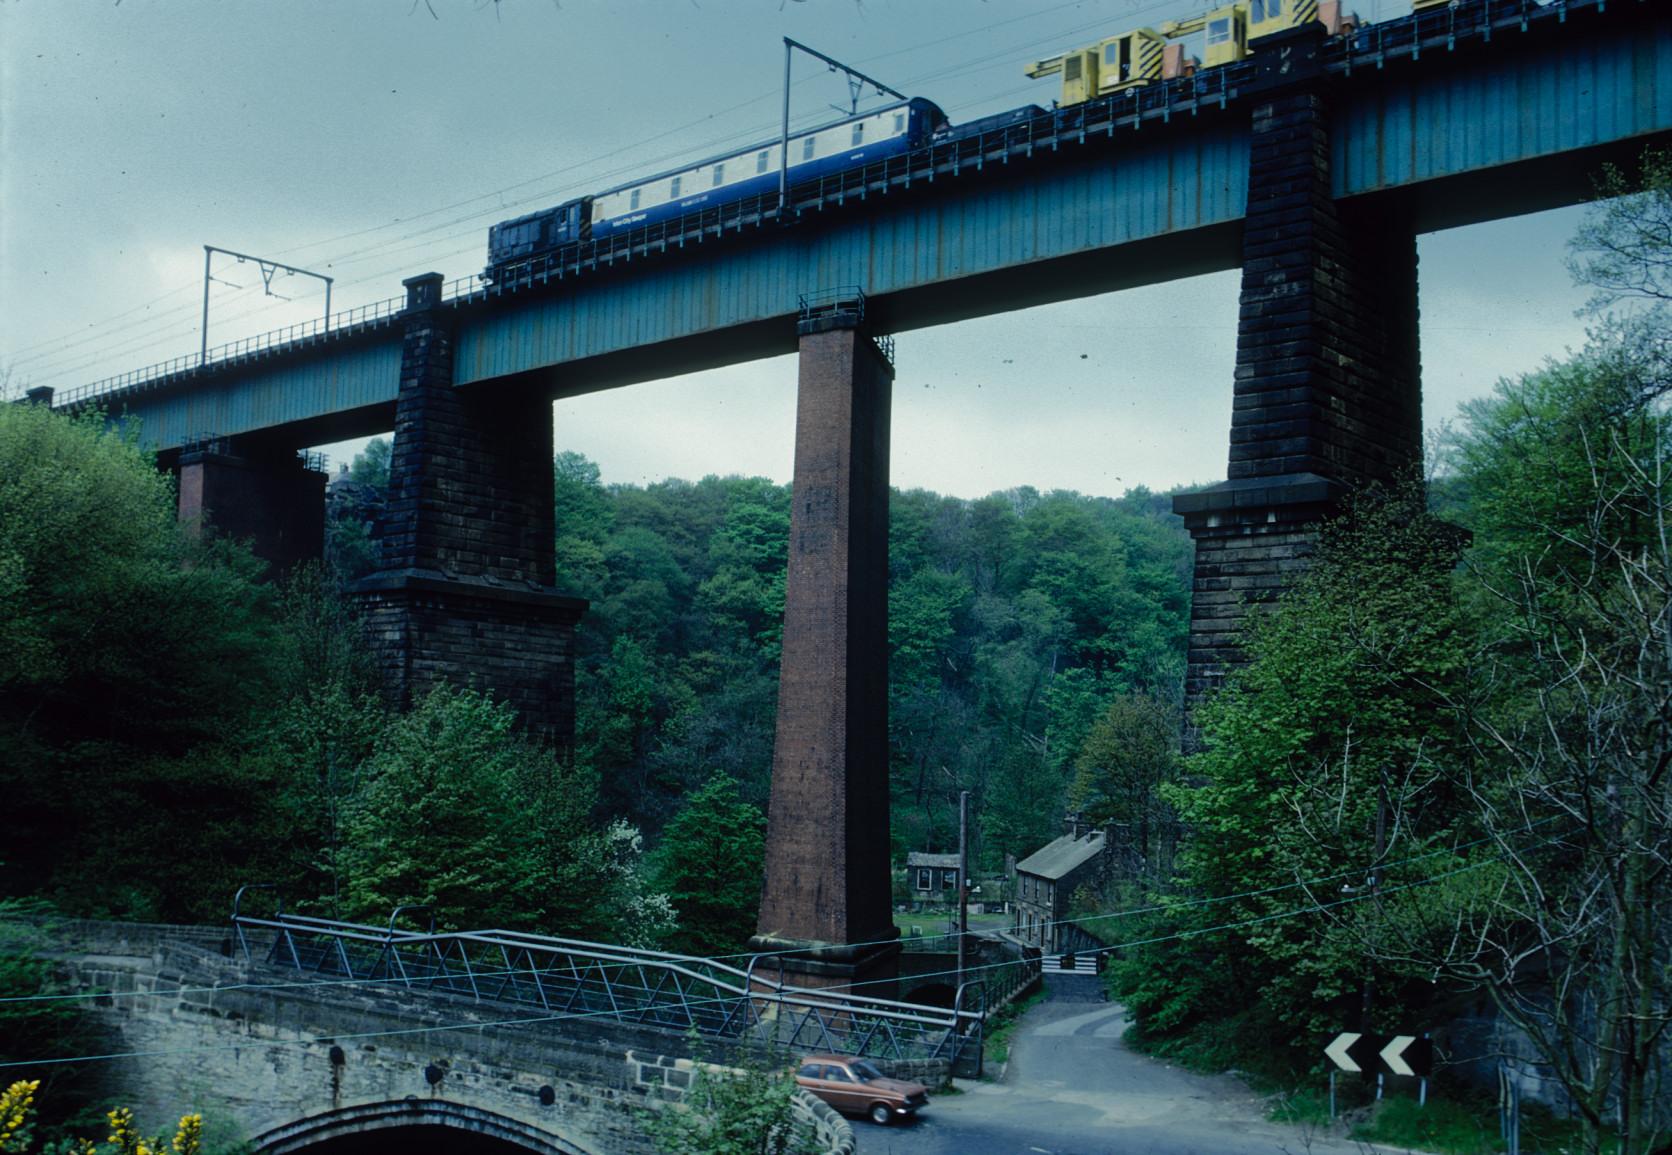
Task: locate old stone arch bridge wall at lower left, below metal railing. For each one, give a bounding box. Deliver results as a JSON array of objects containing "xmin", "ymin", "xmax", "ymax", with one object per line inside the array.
[{"xmin": 34, "ymin": 923, "xmax": 853, "ymax": 1155}]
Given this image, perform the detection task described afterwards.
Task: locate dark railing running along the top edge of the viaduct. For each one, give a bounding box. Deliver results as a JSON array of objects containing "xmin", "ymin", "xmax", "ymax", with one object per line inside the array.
[{"xmin": 54, "ymin": 0, "xmax": 1618, "ymax": 416}]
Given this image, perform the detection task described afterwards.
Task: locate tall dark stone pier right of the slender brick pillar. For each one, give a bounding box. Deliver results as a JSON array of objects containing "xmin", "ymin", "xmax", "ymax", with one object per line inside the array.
[{"xmin": 1174, "ymin": 28, "xmax": 1423, "ymax": 707}]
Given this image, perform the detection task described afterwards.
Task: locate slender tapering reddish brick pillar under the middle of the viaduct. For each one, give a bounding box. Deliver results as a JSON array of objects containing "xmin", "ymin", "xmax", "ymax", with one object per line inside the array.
[{"xmin": 754, "ymin": 316, "xmax": 898, "ymax": 993}]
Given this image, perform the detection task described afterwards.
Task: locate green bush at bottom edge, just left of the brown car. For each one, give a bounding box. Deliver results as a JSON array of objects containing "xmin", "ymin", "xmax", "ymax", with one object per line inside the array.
[{"xmin": 642, "ymin": 1063, "xmax": 819, "ymax": 1155}]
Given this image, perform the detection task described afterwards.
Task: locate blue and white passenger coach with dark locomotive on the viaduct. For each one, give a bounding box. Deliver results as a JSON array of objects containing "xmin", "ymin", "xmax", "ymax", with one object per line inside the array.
[{"xmin": 483, "ymin": 97, "xmax": 946, "ymax": 281}]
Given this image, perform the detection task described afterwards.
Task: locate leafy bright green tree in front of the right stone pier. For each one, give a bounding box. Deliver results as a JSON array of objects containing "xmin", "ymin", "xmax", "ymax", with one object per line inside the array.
[{"xmin": 1104, "ymin": 488, "xmax": 1466, "ymax": 1070}]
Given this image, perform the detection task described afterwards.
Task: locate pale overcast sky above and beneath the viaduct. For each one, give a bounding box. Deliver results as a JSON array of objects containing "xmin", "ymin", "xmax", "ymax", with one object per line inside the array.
[{"xmin": 0, "ymin": 0, "xmax": 1583, "ymax": 496}]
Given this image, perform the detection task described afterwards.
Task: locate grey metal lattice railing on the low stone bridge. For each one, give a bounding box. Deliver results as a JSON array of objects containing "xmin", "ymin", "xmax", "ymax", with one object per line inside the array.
[{"xmin": 232, "ymin": 908, "xmax": 986, "ymax": 1073}]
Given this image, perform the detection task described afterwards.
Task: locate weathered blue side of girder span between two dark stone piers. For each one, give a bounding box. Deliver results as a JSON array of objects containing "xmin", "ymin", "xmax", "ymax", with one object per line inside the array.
[{"xmin": 456, "ymin": 119, "xmax": 1247, "ymax": 389}]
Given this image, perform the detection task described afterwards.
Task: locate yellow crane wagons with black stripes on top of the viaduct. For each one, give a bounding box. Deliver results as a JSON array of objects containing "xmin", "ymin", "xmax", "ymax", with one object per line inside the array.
[{"xmin": 1027, "ymin": 0, "xmax": 1350, "ymax": 105}]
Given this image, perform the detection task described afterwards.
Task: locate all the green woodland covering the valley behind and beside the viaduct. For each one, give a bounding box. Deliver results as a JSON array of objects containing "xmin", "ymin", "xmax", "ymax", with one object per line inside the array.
[{"xmin": 0, "ymin": 157, "xmax": 1672, "ymax": 1155}]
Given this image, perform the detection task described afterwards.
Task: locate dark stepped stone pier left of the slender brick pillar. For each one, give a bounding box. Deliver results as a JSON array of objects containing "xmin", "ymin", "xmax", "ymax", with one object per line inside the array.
[{"xmin": 354, "ymin": 274, "xmax": 587, "ymax": 749}]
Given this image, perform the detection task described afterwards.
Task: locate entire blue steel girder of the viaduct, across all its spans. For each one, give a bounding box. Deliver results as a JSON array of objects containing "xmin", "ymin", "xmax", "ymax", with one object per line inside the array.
[{"xmin": 71, "ymin": 0, "xmax": 1672, "ymax": 451}]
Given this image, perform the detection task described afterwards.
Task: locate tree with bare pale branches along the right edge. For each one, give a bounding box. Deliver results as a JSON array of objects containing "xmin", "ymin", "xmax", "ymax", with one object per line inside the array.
[{"xmin": 1373, "ymin": 335, "xmax": 1672, "ymax": 1155}]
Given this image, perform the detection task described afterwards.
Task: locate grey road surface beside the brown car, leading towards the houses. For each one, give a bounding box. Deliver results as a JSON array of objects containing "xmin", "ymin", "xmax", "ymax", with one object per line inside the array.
[{"xmin": 853, "ymin": 974, "xmax": 1397, "ymax": 1155}]
